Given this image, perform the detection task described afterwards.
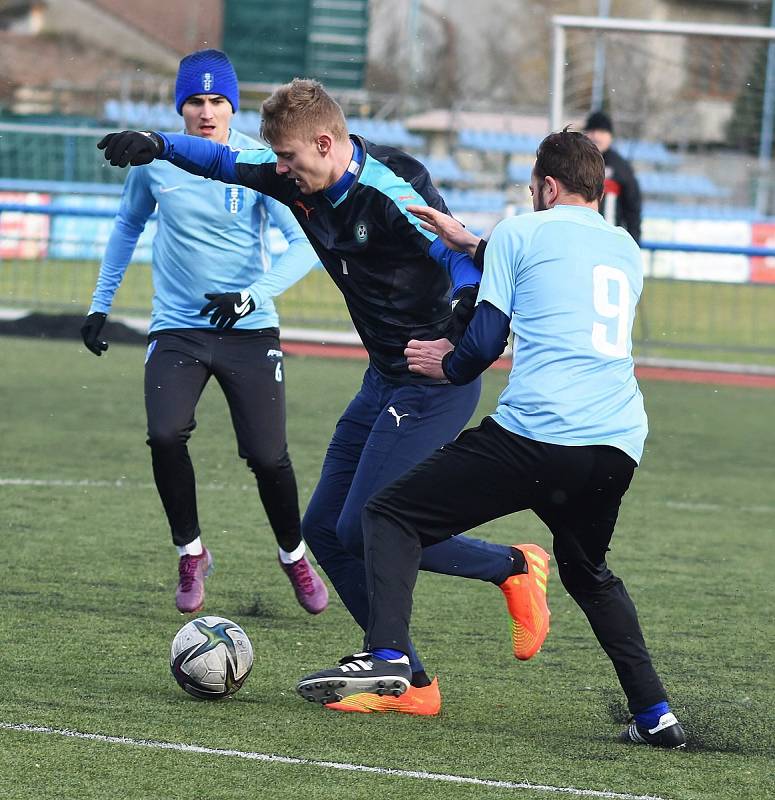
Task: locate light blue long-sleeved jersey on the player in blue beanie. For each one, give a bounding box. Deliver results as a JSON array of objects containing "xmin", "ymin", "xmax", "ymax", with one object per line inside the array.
[{"xmin": 89, "ymin": 130, "xmax": 318, "ymax": 331}]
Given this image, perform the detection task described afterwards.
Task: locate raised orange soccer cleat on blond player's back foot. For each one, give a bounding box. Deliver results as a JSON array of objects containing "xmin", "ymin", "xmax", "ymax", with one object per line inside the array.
[{"xmin": 499, "ymin": 544, "xmax": 550, "ymax": 661}]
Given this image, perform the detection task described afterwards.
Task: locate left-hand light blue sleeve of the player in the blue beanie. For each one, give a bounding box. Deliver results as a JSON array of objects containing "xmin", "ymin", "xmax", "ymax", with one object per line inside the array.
[{"xmin": 89, "ymin": 167, "xmax": 156, "ymax": 314}]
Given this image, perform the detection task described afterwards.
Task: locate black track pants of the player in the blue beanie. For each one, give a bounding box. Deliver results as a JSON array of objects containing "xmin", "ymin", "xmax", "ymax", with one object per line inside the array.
[{"xmin": 145, "ymin": 328, "xmax": 301, "ymax": 550}]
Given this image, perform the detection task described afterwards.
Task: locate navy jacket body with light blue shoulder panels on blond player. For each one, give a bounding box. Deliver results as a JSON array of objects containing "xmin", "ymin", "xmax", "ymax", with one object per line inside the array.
[{"xmin": 224, "ymin": 136, "xmax": 466, "ymax": 383}]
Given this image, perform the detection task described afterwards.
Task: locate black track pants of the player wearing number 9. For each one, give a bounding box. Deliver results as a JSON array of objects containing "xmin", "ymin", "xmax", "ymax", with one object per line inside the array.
[{"xmin": 363, "ymin": 417, "xmax": 665, "ymax": 712}]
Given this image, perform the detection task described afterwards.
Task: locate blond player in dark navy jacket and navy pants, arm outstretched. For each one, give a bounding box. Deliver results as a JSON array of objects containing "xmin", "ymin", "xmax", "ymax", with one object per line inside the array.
[{"xmin": 100, "ymin": 79, "xmax": 544, "ymax": 714}]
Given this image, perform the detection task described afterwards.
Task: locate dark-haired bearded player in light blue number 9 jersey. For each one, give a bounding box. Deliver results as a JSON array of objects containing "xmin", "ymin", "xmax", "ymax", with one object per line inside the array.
[{"xmin": 299, "ymin": 129, "xmax": 686, "ymax": 748}]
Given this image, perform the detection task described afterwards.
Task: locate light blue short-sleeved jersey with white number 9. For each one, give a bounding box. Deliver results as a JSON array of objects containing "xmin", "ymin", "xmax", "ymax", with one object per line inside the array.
[{"xmin": 478, "ymin": 205, "xmax": 648, "ymax": 463}]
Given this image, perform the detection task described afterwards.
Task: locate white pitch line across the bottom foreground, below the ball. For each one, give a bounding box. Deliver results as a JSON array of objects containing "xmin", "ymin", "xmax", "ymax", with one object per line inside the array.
[{"xmin": 0, "ymin": 722, "xmax": 665, "ymax": 800}]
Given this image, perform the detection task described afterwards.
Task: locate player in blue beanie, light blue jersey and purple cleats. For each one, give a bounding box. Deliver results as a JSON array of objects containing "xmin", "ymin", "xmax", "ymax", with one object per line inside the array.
[{"xmin": 81, "ymin": 50, "xmax": 328, "ymax": 614}]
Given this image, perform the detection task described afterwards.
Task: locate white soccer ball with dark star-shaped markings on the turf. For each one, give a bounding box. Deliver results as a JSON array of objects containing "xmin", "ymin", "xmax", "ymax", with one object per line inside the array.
[{"xmin": 170, "ymin": 616, "xmax": 253, "ymax": 700}]
